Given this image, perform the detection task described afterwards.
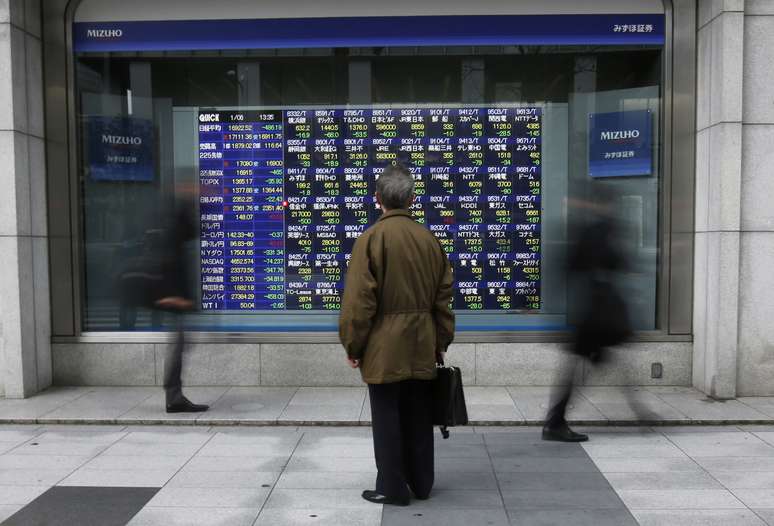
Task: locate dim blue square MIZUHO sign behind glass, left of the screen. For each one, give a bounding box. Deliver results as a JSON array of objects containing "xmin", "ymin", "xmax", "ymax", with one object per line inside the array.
[{"xmin": 84, "ymin": 116, "xmax": 154, "ymax": 181}]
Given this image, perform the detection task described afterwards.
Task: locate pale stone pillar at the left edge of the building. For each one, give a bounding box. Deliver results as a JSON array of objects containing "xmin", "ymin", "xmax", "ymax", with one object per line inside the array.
[{"xmin": 0, "ymin": 0, "xmax": 52, "ymax": 397}]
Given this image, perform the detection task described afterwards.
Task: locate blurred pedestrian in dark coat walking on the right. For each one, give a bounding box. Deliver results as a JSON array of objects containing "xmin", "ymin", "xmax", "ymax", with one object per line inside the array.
[{"xmin": 543, "ymin": 194, "xmax": 631, "ymax": 442}]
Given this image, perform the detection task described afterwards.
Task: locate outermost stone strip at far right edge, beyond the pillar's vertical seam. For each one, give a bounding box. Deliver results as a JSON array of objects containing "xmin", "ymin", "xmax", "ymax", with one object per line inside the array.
[{"xmin": 737, "ymin": 0, "xmax": 774, "ymax": 396}]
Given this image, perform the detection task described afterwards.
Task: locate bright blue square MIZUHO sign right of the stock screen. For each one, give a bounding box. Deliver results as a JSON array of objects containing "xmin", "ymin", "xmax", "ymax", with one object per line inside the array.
[{"xmin": 589, "ymin": 110, "xmax": 653, "ymax": 177}]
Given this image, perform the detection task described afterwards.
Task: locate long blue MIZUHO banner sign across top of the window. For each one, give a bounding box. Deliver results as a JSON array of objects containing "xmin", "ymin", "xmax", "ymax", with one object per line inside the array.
[{"xmin": 73, "ymin": 14, "xmax": 664, "ymax": 52}]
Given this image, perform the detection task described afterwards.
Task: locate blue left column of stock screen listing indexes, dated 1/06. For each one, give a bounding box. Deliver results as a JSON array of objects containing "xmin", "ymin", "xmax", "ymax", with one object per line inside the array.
[{"xmin": 199, "ymin": 111, "xmax": 285, "ymax": 310}]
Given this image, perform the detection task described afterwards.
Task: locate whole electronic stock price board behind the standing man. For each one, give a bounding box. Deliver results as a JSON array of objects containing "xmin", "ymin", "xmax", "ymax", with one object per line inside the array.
[{"xmin": 198, "ymin": 107, "xmax": 542, "ymax": 311}]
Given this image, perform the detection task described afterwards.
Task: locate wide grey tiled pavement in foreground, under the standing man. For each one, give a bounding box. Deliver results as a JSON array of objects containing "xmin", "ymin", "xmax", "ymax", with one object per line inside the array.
[{"xmin": 0, "ymin": 425, "xmax": 774, "ymax": 526}]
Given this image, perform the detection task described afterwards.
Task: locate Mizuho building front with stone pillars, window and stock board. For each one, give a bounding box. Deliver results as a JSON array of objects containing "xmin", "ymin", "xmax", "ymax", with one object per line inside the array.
[{"xmin": 0, "ymin": 0, "xmax": 774, "ymax": 398}]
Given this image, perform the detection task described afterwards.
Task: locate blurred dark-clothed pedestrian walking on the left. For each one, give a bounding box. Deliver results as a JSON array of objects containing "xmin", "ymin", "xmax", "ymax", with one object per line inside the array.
[{"xmin": 155, "ymin": 188, "xmax": 209, "ymax": 413}]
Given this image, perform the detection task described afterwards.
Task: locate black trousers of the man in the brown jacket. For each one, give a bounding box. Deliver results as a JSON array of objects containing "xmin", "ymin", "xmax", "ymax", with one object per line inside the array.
[{"xmin": 368, "ymin": 380, "xmax": 435, "ymax": 499}]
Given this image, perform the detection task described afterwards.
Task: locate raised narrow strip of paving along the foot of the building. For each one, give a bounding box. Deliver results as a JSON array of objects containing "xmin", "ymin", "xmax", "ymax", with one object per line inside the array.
[{"xmin": 0, "ymin": 387, "xmax": 774, "ymax": 426}]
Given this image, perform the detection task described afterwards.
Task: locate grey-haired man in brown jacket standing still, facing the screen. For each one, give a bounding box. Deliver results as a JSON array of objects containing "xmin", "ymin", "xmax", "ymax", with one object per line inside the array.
[{"xmin": 339, "ymin": 166, "xmax": 454, "ymax": 506}]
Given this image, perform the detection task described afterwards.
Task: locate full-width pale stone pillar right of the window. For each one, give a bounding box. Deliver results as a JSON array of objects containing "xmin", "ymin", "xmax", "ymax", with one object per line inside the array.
[{"xmin": 693, "ymin": 0, "xmax": 774, "ymax": 398}]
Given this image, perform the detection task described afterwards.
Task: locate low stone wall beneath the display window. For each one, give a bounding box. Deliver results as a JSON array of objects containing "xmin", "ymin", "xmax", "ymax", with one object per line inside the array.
[{"xmin": 52, "ymin": 342, "xmax": 691, "ymax": 387}]
